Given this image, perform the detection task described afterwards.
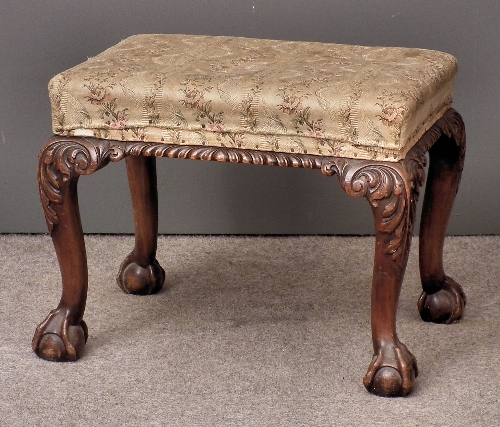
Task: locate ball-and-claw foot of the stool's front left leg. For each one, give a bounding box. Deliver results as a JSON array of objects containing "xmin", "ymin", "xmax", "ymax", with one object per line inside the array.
[{"xmin": 32, "ymin": 308, "xmax": 88, "ymax": 362}]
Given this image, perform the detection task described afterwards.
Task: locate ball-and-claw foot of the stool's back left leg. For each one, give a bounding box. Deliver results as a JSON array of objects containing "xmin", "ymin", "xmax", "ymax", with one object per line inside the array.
[{"xmin": 116, "ymin": 254, "xmax": 165, "ymax": 295}]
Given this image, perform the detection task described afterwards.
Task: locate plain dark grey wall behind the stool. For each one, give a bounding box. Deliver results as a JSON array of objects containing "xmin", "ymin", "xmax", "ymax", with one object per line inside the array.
[{"xmin": 0, "ymin": 0, "xmax": 500, "ymax": 234}]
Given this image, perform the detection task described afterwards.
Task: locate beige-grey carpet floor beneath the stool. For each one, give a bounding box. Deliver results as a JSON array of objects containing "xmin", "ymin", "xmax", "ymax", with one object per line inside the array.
[{"xmin": 0, "ymin": 235, "xmax": 500, "ymax": 427}]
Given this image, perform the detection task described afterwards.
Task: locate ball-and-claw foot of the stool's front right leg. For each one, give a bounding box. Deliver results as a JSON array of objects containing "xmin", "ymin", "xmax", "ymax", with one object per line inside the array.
[{"xmin": 363, "ymin": 343, "xmax": 418, "ymax": 397}]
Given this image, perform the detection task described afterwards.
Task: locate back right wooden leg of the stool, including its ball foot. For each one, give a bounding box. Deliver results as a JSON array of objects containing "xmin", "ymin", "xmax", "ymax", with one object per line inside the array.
[{"xmin": 418, "ymin": 110, "xmax": 467, "ymax": 323}]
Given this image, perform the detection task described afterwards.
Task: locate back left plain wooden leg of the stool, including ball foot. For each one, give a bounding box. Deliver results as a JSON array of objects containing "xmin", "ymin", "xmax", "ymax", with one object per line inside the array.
[{"xmin": 117, "ymin": 156, "xmax": 165, "ymax": 295}]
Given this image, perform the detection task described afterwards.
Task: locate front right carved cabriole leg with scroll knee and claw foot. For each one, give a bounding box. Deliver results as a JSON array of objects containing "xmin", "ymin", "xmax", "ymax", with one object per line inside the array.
[{"xmin": 322, "ymin": 150, "xmax": 425, "ymax": 396}]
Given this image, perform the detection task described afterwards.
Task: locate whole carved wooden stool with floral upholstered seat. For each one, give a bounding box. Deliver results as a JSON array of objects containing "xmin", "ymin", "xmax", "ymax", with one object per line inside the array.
[{"xmin": 33, "ymin": 35, "xmax": 466, "ymax": 396}]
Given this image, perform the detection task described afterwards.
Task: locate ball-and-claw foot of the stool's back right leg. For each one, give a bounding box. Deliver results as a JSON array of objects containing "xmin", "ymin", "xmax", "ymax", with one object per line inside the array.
[{"xmin": 418, "ymin": 276, "xmax": 467, "ymax": 324}]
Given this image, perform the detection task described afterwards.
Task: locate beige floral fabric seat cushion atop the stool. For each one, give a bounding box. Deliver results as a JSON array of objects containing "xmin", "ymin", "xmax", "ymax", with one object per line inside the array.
[{"xmin": 49, "ymin": 35, "xmax": 457, "ymax": 161}]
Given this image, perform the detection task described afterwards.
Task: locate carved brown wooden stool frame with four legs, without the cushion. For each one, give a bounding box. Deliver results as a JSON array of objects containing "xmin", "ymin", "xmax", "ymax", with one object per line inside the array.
[{"xmin": 33, "ymin": 109, "xmax": 466, "ymax": 396}]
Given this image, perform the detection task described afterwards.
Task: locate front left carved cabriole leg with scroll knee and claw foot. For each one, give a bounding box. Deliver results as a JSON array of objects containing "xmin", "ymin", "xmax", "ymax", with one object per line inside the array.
[{"xmin": 32, "ymin": 137, "xmax": 124, "ymax": 361}]
